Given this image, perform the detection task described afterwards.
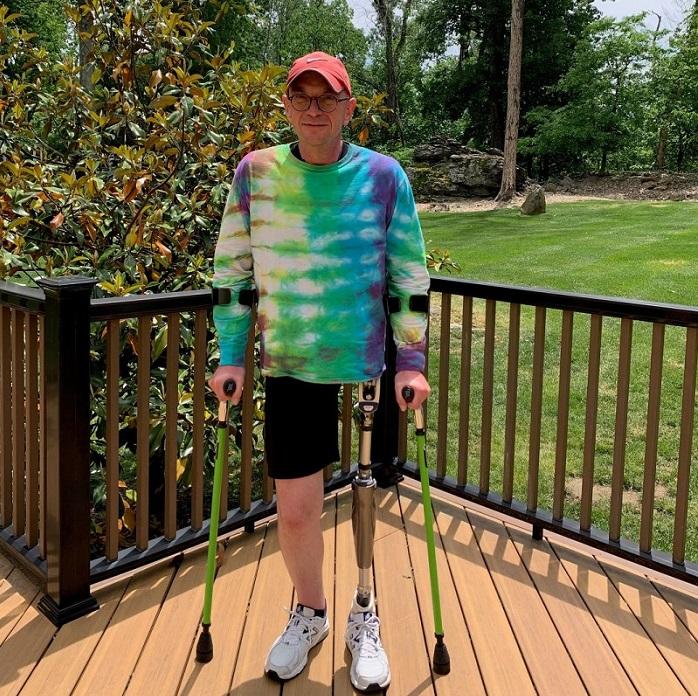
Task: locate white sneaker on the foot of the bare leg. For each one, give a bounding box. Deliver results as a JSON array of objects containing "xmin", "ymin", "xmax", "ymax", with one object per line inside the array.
[{"xmin": 264, "ymin": 604, "xmax": 330, "ymax": 681}]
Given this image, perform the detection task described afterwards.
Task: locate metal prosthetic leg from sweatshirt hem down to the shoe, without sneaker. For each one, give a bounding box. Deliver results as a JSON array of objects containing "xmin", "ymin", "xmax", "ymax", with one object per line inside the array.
[{"xmin": 351, "ymin": 378, "xmax": 380, "ymax": 607}]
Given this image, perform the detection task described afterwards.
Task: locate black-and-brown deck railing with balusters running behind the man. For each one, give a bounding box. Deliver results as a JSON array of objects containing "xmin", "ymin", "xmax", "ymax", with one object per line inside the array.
[{"xmin": 0, "ymin": 277, "xmax": 698, "ymax": 623}]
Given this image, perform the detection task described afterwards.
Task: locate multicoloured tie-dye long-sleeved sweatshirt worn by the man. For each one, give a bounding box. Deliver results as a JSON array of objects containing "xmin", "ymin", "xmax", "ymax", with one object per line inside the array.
[{"xmin": 213, "ymin": 139, "xmax": 429, "ymax": 383}]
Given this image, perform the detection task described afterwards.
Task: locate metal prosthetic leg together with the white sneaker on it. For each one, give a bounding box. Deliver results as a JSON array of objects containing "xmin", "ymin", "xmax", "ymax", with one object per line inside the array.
[{"xmin": 345, "ymin": 379, "xmax": 390, "ymax": 693}]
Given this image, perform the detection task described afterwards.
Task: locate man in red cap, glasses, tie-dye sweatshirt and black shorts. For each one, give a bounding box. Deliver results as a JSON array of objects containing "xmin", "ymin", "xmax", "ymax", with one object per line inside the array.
[{"xmin": 210, "ymin": 52, "xmax": 430, "ymax": 691}]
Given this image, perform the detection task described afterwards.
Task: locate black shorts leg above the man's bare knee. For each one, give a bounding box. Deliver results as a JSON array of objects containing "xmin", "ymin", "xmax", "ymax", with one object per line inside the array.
[{"xmin": 264, "ymin": 377, "xmax": 340, "ymax": 479}]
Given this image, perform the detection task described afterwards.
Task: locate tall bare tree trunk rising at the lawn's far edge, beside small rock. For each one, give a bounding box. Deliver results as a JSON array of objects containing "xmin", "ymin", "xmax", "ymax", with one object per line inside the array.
[{"xmin": 495, "ymin": 0, "xmax": 524, "ymax": 203}]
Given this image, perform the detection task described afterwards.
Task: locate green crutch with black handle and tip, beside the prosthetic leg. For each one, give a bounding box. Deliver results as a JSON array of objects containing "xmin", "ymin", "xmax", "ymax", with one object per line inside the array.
[{"xmin": 402, "ymin": 387, "xmax": 451, "ymax": 674}]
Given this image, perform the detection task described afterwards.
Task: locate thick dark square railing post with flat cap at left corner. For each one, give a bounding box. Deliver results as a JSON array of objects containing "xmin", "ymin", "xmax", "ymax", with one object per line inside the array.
[{"xmin": 37, "ymin": 277, "xmax": 99, "ymax": 626}]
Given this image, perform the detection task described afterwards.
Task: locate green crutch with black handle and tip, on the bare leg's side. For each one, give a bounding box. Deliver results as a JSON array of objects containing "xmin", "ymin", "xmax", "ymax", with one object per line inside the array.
[{"xmin": 196, "ymin": 379, "xmax": 235, "ymax": 662}]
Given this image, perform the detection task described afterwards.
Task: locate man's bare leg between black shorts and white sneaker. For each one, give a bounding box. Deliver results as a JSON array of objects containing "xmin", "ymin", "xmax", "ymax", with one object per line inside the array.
[{"xmin": 276, "ymin": 471, "xmax": 325, "ymax": 609}]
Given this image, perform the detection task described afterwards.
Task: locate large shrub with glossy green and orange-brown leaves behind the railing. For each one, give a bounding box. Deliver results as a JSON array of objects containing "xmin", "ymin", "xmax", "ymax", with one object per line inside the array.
[{"xmin": 0, "ymin": 0, "xmax": 426, "ymax": 553}]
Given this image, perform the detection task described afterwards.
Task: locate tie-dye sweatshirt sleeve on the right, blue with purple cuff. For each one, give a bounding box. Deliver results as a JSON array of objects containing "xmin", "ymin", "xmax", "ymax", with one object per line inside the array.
[{"xmin": 386, "ymin": 173, "xmax": 429, "ymax": 372}]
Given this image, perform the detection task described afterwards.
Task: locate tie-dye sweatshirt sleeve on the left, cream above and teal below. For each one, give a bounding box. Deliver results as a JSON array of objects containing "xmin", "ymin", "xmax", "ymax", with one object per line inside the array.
[{"xmin": 213, "ymin": 157, "xmax": 253, "ymax": 366}]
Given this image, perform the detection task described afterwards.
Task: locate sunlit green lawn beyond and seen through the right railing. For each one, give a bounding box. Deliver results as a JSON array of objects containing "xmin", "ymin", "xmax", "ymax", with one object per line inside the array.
[{"xmin": 411, "ymin": 201, "xmax": 698, "ymax": 561}]
